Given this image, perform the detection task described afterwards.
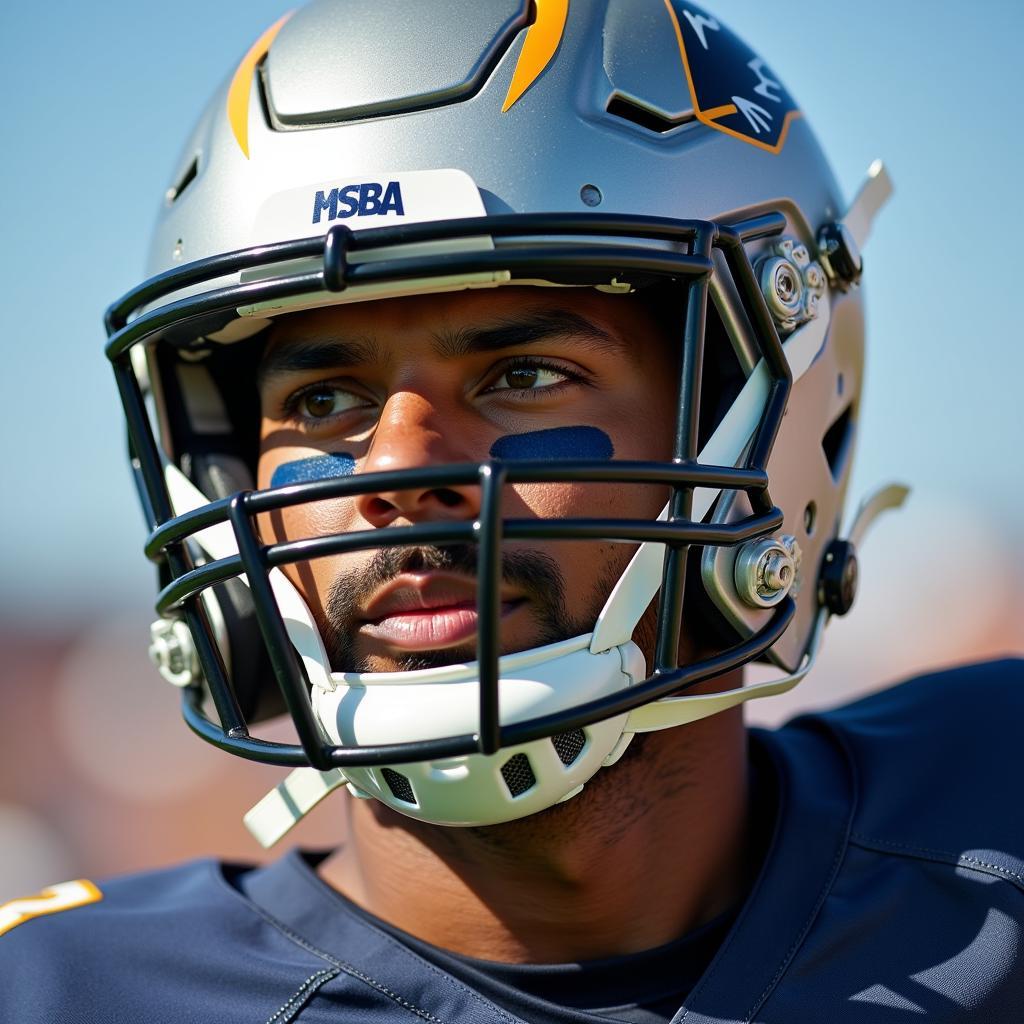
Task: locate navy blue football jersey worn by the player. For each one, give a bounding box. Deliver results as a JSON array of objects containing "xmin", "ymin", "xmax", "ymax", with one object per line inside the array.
[{"xmin": 0, "ymin": 660, "xmax": 1024, "ymax": 1024}]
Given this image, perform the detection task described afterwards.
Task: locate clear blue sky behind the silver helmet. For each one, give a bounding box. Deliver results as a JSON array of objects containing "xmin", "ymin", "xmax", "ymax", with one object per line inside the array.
[{"xmin": 0, "ymin": 0, "xmax": 1024, "ymax": 618}]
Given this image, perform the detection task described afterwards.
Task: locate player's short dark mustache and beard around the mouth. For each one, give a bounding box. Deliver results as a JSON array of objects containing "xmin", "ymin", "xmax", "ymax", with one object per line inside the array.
[{"xmin": 324, "ymin": 544, "xmax": 593, "ymax": 672}]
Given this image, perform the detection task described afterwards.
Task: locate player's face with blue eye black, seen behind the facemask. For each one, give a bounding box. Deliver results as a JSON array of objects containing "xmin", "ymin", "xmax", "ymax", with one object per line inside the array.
[{"xmin": 259, "ymin": 288, "xmax": 676, "ymax": 672}]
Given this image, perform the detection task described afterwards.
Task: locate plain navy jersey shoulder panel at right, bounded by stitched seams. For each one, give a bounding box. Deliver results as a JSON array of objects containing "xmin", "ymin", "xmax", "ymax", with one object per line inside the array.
[{"xmin": 793, "ymin": 658, "xmax": 1024, "ymax": 887}]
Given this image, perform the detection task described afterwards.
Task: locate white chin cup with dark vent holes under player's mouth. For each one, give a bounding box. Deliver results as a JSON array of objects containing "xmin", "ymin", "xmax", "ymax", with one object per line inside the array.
[{"xmin": 312, "ymin": 635, "xmax": 645, "ymax": 825}]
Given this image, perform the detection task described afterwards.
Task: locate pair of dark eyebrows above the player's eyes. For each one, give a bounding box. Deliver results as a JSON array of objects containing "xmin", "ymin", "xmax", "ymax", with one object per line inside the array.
[{"xmin": 256, "ymin": 309, "xmax": 629, "ymax": 388}]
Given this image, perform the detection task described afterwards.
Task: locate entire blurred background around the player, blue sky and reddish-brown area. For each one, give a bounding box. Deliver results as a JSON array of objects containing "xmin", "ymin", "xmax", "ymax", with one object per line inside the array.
[{"xmin": 0, "ymin": 0, "xmax": 1024, "ymax": 901}]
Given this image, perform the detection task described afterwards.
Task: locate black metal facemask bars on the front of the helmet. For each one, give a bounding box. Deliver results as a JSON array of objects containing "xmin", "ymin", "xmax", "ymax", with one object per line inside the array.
[{"xmin": 106, "ymin": 214, "xmax": 795, "ymax": 770}]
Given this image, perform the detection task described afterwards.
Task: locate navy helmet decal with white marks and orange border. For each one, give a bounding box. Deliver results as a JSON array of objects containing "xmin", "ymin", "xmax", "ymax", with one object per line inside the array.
[{"xmin": 665, "ymin": 0, "xmax": 801, "ymax": 154}]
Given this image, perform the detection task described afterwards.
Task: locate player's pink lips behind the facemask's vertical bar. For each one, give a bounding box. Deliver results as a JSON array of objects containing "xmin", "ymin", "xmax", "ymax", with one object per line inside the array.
[{"xmin": 359, "ymin": 572, "xmax": 525, "ymax": 650}]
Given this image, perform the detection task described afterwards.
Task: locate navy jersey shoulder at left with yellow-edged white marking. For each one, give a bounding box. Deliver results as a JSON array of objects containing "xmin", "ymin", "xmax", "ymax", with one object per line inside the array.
[{"xmin": 0, "ymin": 860, "xmax": 323, "ymax": 1024}]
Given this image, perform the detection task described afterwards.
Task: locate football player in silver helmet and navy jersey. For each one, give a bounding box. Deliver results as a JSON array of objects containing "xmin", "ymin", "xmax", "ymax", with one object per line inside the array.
[{"xmin": 0, "ymin": 0, "xmax": 1024, "ymax": 1024}]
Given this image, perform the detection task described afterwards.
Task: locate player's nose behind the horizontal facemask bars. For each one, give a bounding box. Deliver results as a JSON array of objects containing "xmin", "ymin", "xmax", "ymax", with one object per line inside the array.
[{"xmin": 356, "ymin": 391, "xmax": 480, "ymax": 527}]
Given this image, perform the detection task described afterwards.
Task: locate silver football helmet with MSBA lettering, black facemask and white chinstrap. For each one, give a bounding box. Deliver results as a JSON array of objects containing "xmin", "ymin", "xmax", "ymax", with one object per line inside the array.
[{"xmin": 106, "ymin": 0, "xmax": 898, "ymax": 843}]
